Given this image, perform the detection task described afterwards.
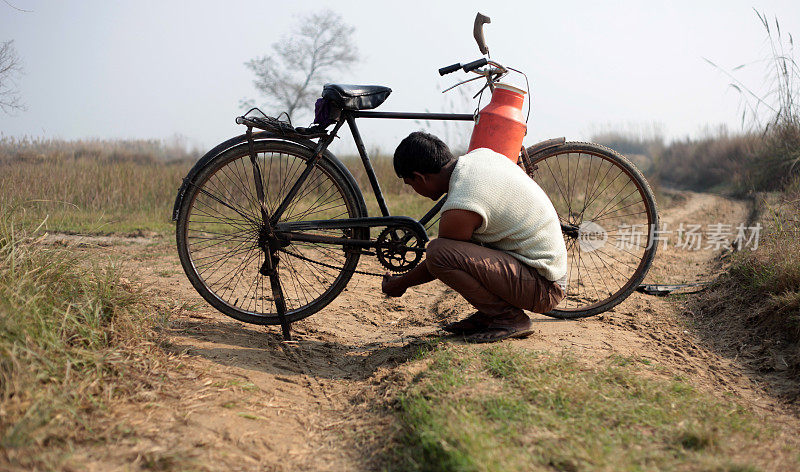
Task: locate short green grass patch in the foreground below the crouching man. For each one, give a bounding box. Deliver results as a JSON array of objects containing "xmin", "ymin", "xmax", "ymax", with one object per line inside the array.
[{"xmin": 384, "ymin": 345, "xmax": 788, "ymax": 471}]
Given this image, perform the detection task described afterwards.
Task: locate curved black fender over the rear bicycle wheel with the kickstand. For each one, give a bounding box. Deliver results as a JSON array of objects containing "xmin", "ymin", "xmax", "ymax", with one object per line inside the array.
[{"xmin": 172, "ymin": 131, "xmax": 367, "ymax": 221}]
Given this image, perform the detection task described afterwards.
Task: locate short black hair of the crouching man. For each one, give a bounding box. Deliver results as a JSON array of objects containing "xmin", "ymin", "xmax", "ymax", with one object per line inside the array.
[{"xmin": 394, "ymin": 131, "xmax": 454, "ymax": 178}]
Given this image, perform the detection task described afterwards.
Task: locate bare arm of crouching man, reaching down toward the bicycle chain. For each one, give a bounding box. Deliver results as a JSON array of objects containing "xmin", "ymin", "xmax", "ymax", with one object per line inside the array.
[{"xmin": 381, "ymin": 210, "xmax": 483, "ymax": 297}]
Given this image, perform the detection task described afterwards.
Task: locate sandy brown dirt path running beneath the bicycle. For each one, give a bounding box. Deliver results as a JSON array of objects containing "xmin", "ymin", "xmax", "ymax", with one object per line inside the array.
[{"xmin": 45, "ymin": 193, "xmax": 797, "ymax": 470}]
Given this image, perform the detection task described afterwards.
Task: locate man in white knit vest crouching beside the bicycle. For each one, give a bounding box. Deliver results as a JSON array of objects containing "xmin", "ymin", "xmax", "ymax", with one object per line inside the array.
[{"xmin": 382, "ymin": 132, "xmax": 567, "ymax": 343}]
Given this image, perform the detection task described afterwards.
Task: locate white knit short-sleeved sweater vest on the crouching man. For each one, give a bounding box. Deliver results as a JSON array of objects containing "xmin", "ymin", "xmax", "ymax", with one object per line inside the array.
[{"xmin": 442, "ymin": 148, "xmax": 567, "ymax": 285}]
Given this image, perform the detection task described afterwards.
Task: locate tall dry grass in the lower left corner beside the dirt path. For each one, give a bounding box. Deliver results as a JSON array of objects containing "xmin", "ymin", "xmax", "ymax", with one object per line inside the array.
[{"xmin": 0, "ymin": 208, "xmax": 175, "ymax": 470}]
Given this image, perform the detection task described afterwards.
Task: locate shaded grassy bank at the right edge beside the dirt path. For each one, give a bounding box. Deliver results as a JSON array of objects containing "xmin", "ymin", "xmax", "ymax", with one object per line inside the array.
[{"xmin": 690, "ymin": 182, "xmax": 800, "ymax": 376}]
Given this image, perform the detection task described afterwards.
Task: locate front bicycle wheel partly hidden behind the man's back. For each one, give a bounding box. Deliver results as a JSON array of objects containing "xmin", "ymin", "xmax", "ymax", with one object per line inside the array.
[{"xmin": 525, "ymin": 142, "xmax": 658, "ymax": 319}]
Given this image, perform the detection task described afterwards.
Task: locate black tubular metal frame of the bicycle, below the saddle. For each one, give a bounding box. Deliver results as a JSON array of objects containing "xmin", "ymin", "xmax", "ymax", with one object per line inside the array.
[{"xmin": 269, "ymin": 110, "xmax": 475, "ymax": 227}]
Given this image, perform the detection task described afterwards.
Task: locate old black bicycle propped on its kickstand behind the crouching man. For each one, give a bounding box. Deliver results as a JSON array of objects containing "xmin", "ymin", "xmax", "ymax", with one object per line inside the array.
[{"xmin": 172, "ymin": 14, "xmax": 658, "ymax": 340}]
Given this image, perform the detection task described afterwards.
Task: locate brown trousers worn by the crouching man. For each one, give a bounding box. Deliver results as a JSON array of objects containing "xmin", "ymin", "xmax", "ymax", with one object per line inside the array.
[{"xmin": 426, "ymin": 238, "xmax": 565, "ymax": 324}]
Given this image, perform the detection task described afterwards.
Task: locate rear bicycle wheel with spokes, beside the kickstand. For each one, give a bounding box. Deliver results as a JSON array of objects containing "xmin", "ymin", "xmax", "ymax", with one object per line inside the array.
[{"xmin": 176, "ymin": 141, "xmax": 368, "ymax": 325}]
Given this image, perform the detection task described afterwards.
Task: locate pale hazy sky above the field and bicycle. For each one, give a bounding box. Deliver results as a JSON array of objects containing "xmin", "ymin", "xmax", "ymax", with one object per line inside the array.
[{"xmin": 0, "ymin": 0, "xmax": 800, "ymax": 155}]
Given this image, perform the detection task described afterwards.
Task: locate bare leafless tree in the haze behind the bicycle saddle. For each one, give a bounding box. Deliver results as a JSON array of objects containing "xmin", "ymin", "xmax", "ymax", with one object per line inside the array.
[{"xmin": 242, "ymin": 10, "xmax": 358, "ymax": 123}]
